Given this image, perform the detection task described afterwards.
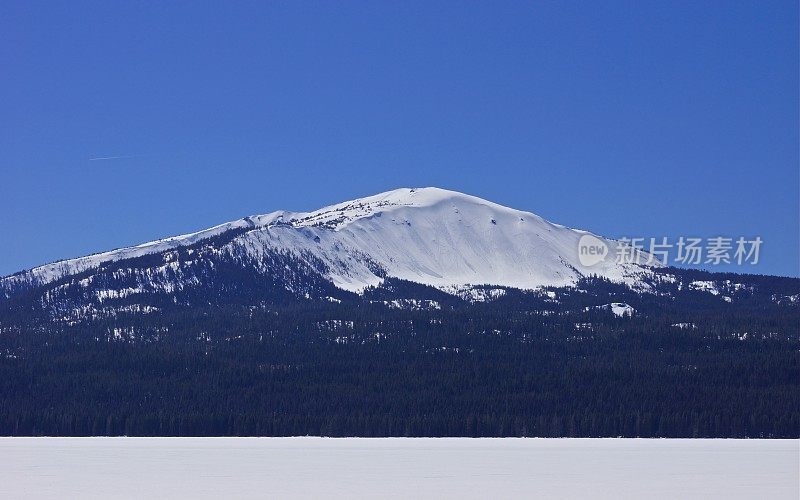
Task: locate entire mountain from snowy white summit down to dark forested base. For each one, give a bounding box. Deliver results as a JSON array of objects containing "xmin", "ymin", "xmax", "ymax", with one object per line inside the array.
[{"xmin": 0, "ymin": 189, "xmax": 800, "ymax": 438}]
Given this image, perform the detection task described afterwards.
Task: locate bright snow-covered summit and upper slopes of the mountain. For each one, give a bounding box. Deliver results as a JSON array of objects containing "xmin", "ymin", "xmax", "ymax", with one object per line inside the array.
[{"xmin": 0, "ymin": 188, "xmax": 659, "ymax": 295}]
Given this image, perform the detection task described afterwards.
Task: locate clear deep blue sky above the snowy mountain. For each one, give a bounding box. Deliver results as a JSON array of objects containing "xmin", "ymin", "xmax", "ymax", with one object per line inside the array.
[{"xmin": 0, "ymin": 0, "xmax": 800, "ymax": 275}]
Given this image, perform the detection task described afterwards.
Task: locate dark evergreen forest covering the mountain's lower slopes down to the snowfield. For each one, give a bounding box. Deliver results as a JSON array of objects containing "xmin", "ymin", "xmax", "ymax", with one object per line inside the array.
[{"xmin": 0, "ymin": 270, "xmax": 800, "ymax": 438}]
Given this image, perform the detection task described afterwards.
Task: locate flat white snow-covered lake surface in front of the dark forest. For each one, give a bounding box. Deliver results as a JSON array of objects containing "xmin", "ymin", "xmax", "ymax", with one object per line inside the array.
[{"xmin": 0, "ymin": 438, "xmax": 800, "ymax": 499}]
